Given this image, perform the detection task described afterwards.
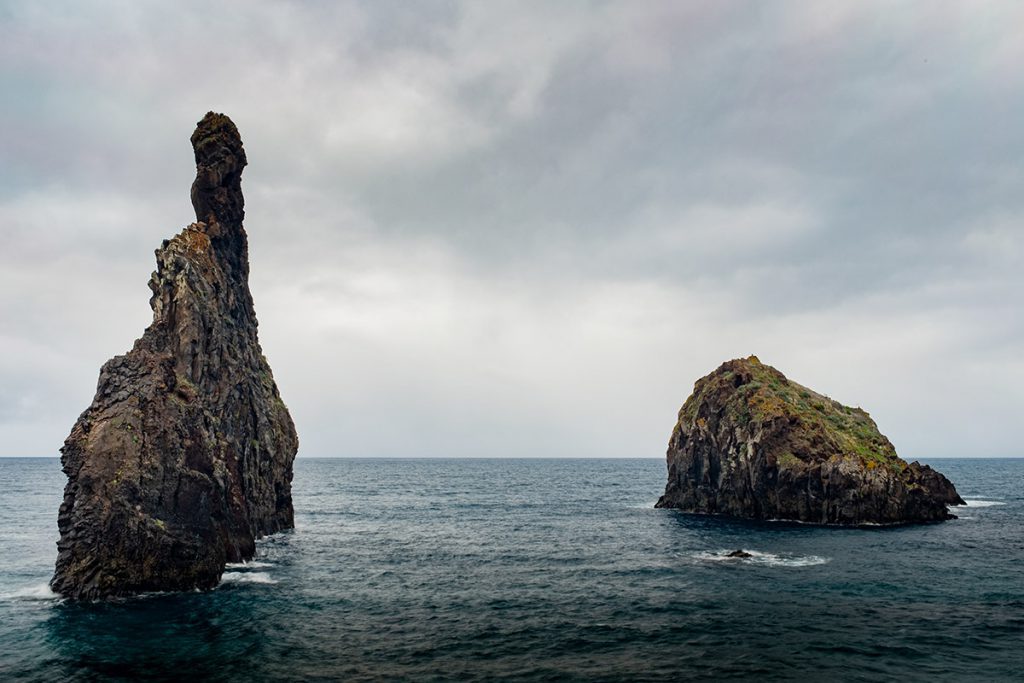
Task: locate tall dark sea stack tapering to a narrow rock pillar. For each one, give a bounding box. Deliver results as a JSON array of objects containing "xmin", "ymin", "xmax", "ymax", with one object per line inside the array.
[{"xmin": 50, "ymin": 112, "xmax": 298, "ymax": 599}]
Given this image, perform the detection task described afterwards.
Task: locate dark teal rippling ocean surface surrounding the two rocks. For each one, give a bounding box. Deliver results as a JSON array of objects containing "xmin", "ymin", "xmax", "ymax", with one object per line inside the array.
[{"xmin": 0, "ymin": 459, "xmax": 1024, "ymax": 683}]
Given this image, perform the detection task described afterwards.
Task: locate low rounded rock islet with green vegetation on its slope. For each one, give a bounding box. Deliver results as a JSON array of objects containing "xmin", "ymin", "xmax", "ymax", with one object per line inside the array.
[{"xmin": 656, "ymin": 356, "xmax": 964, "ymax": 525}]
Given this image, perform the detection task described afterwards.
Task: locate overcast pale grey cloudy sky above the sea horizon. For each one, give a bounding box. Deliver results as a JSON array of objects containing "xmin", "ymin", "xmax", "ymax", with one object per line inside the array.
[{"xmin": 0, "ymin": 0, "xmax": 1024, "ymax": 460}]
